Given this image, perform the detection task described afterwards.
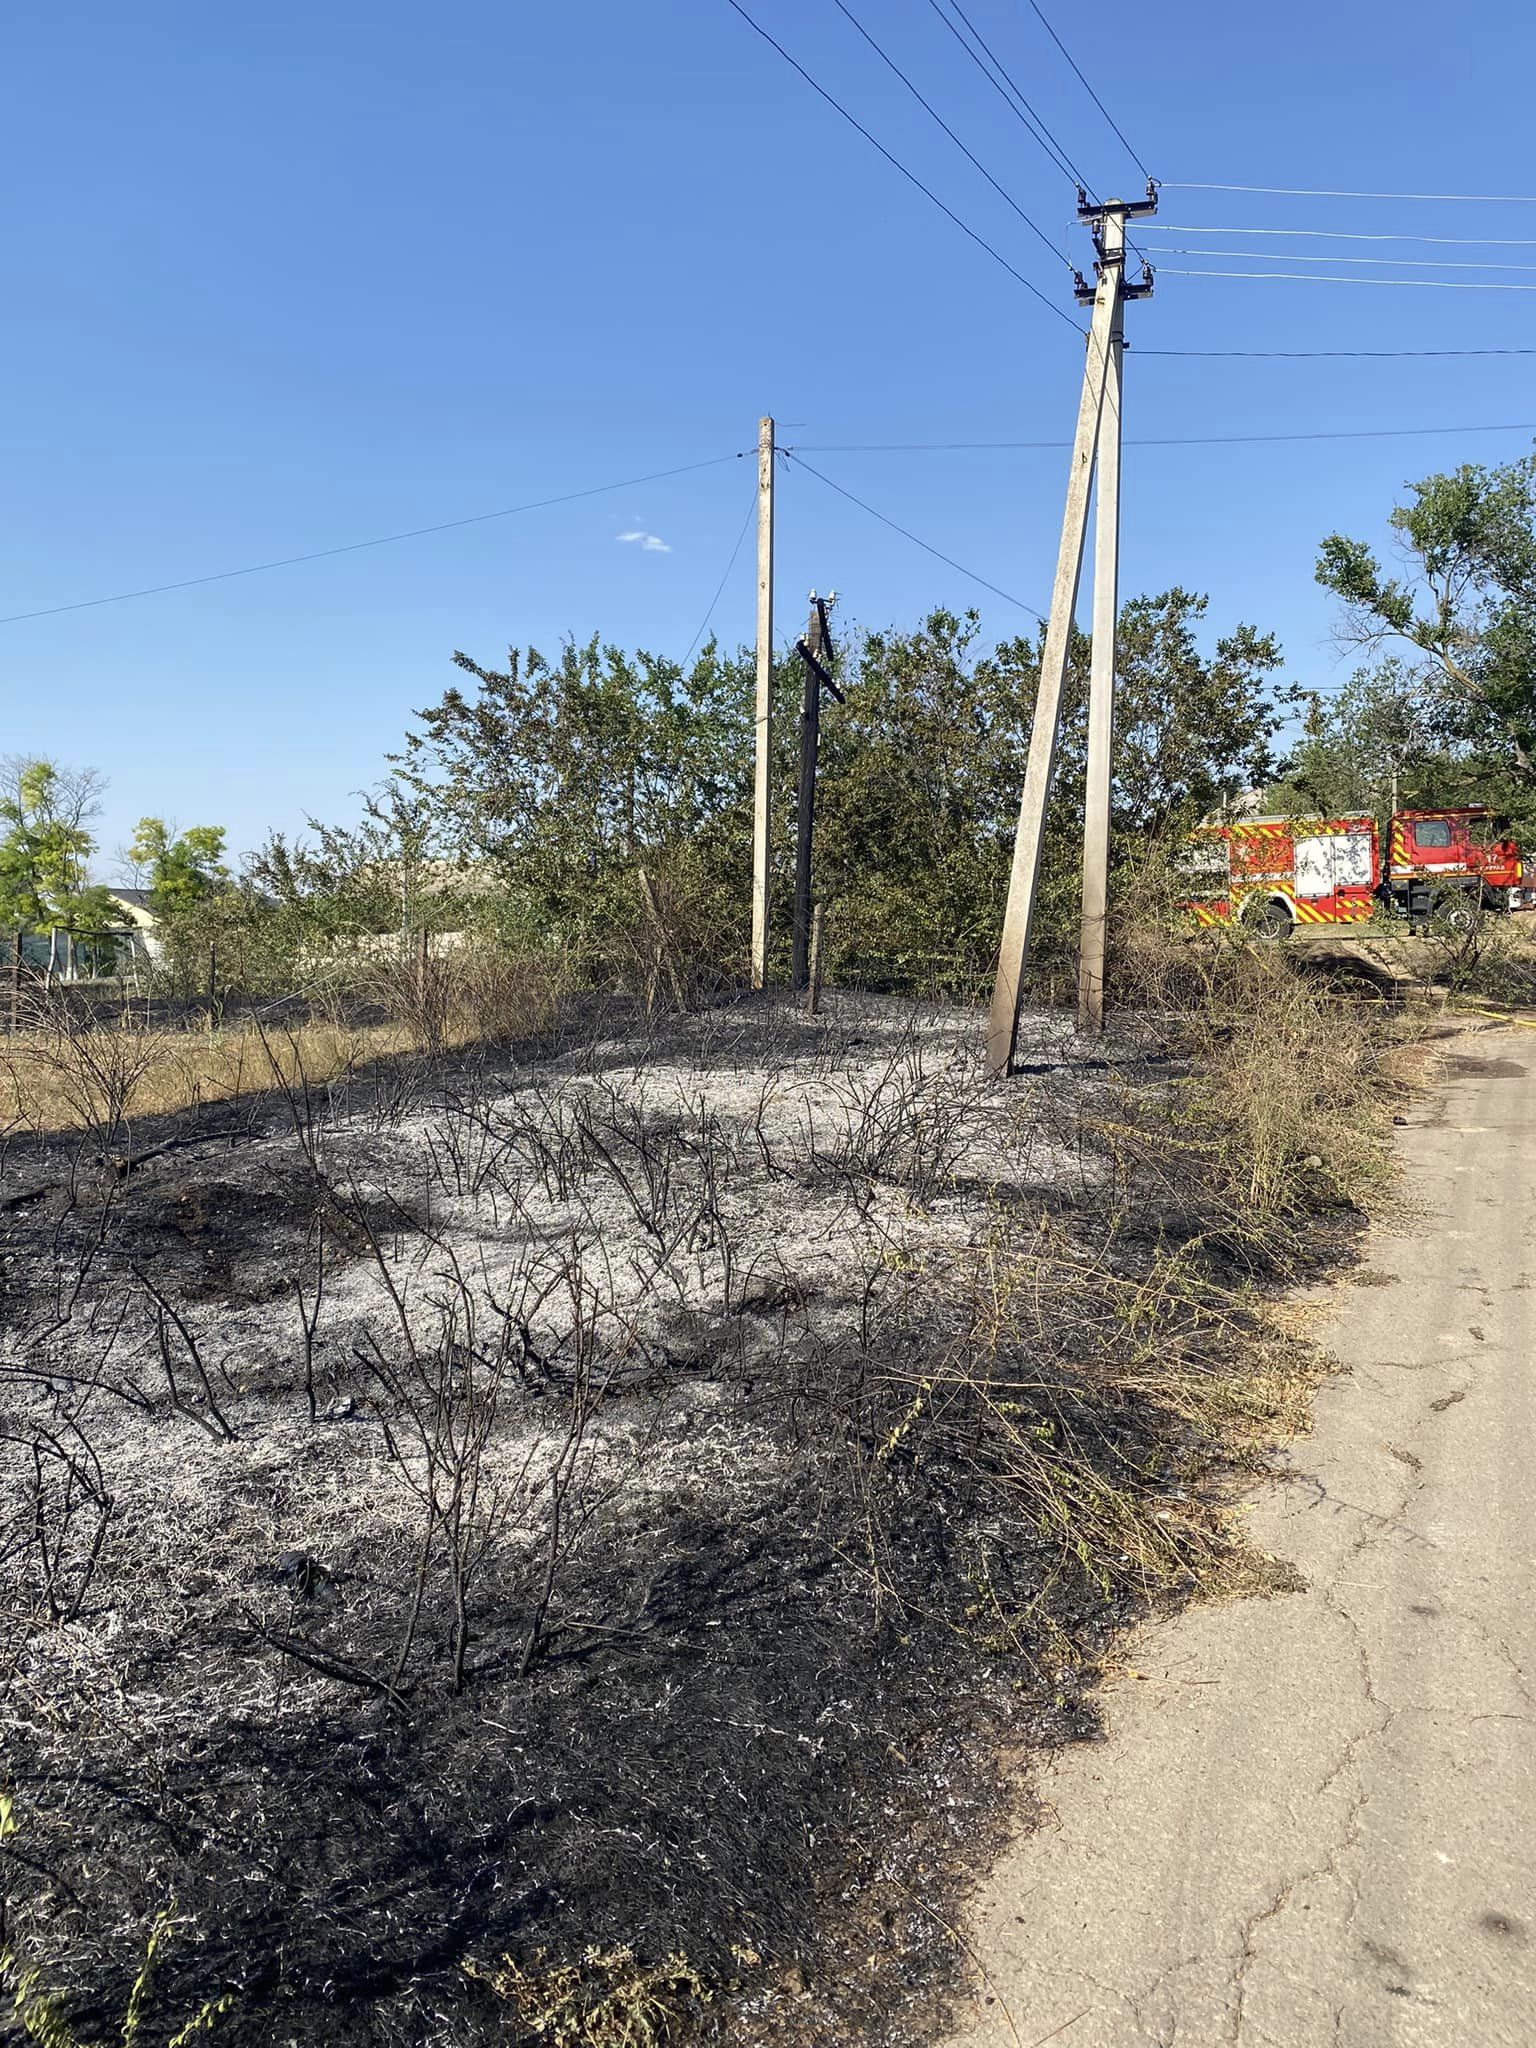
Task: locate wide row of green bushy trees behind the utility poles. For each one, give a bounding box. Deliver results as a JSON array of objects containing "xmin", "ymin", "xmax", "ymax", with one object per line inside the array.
[{"xmin": 240, "ymin": 590, "xmax": 1280, "ymax": 1003}]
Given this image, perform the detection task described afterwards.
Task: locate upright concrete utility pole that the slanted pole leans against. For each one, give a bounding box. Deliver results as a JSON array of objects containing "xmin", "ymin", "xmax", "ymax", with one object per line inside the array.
[{"xmin": 1077, "ymin": 213, "xmax": 1124, "ymax": 1032}]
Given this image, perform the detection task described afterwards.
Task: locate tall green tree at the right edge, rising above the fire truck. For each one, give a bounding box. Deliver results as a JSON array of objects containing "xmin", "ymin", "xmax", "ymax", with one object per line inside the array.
[{"xmin": 1317, "ymin": 455, "xmax": 1536, "ymax": 791}]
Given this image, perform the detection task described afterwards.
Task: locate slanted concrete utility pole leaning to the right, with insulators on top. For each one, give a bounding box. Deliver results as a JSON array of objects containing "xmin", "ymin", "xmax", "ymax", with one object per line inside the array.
[{"xmin": 987, "ymin": 182, "xmax": 1157, "ymax": 1073}]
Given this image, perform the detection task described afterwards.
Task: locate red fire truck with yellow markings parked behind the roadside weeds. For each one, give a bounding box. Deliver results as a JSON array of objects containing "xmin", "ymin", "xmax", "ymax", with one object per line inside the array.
[{"xmin": 1186, "ymin": 805, "xmax": 1536, "ymax": 936}]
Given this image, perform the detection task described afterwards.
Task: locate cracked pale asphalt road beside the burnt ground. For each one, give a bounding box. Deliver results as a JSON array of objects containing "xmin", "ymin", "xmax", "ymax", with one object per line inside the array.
[{"xmin": 954, "ymin": 1030, "xmax": 1536, "ymax": 2048}]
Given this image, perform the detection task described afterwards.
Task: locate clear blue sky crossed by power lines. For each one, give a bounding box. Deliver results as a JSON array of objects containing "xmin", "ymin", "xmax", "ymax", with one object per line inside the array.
[{"xmin": 0, "ymin": 0, "xmax": 1536, "ymax": 868}]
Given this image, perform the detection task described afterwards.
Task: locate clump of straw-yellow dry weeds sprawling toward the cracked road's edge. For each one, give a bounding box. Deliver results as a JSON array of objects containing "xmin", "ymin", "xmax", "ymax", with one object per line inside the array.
[{"xmin": 897, "ymin": 1217, "xmax": 1333, "ymax": 1667}]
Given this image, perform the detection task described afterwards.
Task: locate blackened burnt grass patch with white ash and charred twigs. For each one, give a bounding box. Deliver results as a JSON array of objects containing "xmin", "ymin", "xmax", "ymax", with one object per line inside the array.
[{"xmin": 0, "ymin": 997, "xmax": 1356, "ymax": 2048}]
